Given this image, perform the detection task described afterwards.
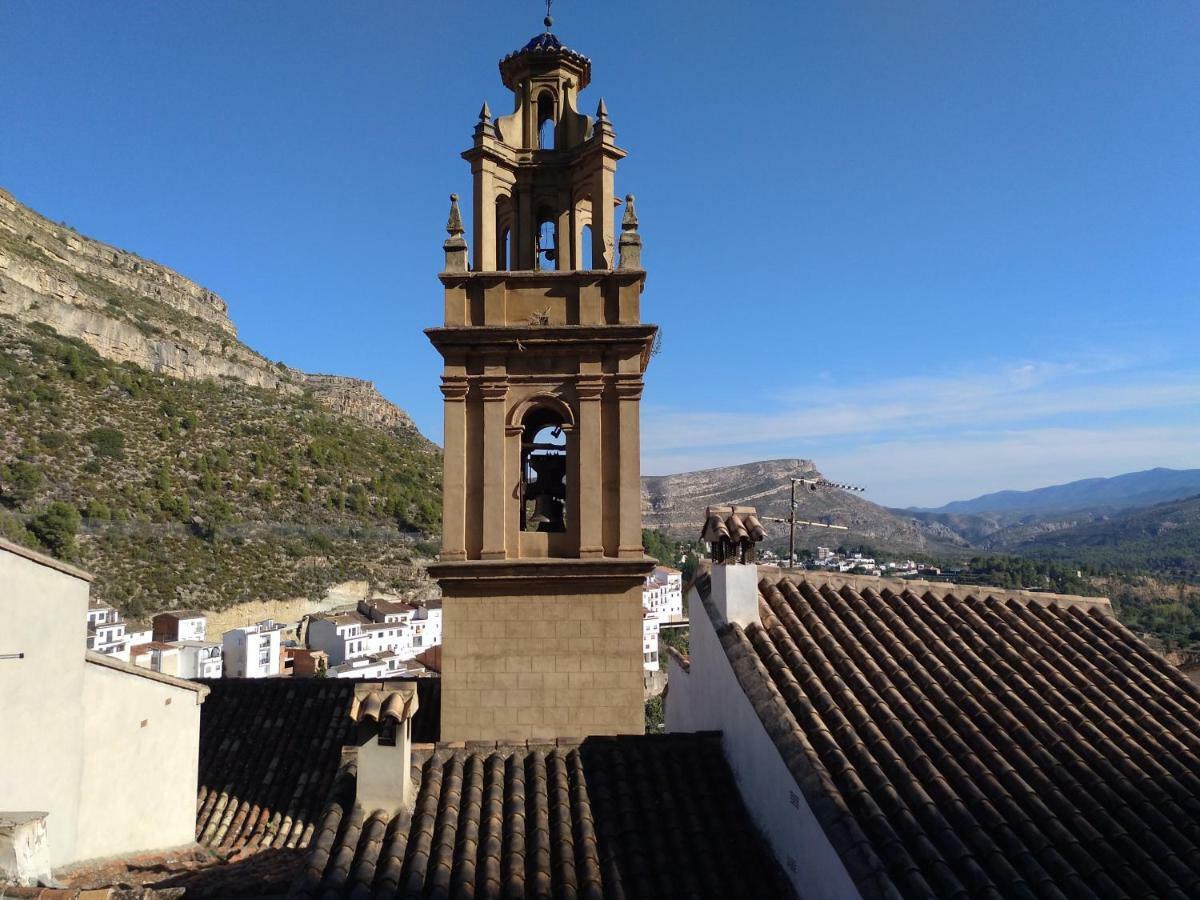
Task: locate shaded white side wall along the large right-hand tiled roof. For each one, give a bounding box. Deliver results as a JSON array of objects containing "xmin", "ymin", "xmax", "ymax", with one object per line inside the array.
[{"xmin": 666, "ymin": 580, "xmax": 859, "ymax": 900}]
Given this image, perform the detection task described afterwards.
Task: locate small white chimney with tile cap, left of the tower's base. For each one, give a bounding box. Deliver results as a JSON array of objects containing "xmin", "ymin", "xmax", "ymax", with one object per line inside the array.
[{"xmin": 350, "ymin": 682, "xmax": 418, "ymax": 812}]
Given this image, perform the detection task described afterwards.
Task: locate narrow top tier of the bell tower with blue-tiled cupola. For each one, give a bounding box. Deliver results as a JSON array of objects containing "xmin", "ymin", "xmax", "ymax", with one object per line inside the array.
[{"xmin": 463, "ymin": 18, "xmax": 625, "ymax": 271}]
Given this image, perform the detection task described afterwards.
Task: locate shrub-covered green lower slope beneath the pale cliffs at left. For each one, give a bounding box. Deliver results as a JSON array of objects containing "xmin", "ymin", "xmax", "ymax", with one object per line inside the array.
[{"xmin": 0, "ymin": 317, "xmax": 440, "ymax": 612}]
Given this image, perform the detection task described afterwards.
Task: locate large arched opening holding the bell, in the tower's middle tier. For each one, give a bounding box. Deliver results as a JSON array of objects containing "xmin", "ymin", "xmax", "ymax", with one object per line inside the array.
[{"xmin": 521, "ymin": 407, "xmax": 568, "ymax": 533}]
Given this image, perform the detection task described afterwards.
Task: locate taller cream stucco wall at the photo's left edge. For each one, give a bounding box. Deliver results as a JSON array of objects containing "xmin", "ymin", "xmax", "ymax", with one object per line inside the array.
[{"xmin": 0, "ymin": 547, "xmax": 89, "ymax": 866}]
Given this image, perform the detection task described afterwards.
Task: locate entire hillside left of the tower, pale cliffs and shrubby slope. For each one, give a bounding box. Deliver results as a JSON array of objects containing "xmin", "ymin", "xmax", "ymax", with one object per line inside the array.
[{"xmin": 0, "ymin": 187, "xmax": 440, "ymax": 616}]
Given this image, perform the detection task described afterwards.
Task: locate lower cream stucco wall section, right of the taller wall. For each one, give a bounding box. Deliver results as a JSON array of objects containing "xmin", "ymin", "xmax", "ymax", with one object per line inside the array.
[{"xmin": 76, "ymin": 659, "xmax": 200, "ymax": 859}]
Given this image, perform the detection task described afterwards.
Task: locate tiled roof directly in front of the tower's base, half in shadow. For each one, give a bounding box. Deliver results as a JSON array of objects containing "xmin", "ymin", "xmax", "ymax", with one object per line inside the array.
[{"xmin": 292, "ymin": 734, "xmax": 792, "ymax": 898}]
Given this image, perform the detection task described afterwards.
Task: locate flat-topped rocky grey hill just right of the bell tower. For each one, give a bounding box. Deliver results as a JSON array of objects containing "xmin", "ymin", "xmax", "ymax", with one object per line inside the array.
[{"xmin": 642, "ymin": 460, "xmax": 966, "ymax": 552}]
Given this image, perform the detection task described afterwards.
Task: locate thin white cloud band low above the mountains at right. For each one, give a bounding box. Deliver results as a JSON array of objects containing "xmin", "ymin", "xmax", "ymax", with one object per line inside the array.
[{"xmin": 643, "ymin": 356, "xmax": 1200, "ymax": 505}]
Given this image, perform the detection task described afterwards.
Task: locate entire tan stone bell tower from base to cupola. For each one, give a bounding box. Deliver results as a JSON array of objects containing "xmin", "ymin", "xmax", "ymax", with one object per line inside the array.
[{"xmin": 426, "ymin": 18, "xmax": 656, "ymax": 740}]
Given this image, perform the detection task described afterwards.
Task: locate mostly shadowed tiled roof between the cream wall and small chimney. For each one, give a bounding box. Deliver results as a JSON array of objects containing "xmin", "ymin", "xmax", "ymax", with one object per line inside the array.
[{"xmin": 196, "ymin": 678, "xmax": 440, "ymax": 850}]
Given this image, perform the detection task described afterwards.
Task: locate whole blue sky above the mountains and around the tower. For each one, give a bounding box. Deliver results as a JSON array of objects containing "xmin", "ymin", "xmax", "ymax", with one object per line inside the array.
[{"xmin": 0, "ymin": 0, "xmax": 1200, "ymax": 505}]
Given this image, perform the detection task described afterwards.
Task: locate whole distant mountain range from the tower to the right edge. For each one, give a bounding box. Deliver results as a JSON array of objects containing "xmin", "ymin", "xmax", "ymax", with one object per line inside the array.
[{"xmin": 642, "ymin": 460, "xmax": 1200, "ymax": 574}]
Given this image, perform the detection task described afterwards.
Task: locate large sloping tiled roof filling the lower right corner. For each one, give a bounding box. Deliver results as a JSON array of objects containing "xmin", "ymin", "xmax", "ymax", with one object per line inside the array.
[{"xmin": 700, "ymin": 574, "xmax": 1200, "ymax": 896}]
